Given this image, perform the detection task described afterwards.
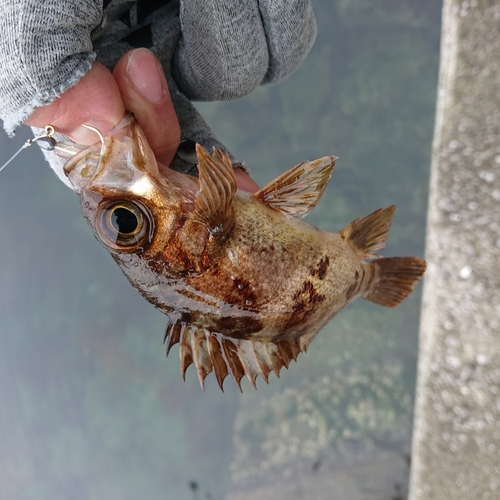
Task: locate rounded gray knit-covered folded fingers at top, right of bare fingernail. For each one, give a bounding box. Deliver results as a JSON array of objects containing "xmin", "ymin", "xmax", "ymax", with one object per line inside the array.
[{"xmin": 172, "ymin": 0, "xmax": 316, "ymax": 100}]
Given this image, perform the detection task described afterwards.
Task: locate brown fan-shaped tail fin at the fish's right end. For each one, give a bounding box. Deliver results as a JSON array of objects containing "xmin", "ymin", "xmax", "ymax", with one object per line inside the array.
[{"xmin": 363, "ymin": 257, "xmax": 427, "ymax": 307}]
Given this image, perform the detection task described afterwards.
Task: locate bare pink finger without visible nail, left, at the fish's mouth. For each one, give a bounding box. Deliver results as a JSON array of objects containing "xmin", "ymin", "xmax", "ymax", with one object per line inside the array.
[{"xmin": 25, "ymin": 62, "xmax": 125, "ymax": 144}]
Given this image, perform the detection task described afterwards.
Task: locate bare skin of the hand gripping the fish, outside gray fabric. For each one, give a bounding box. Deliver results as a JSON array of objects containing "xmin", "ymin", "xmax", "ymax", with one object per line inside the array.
[{"xmin": 25, "ymin": 49, "xmax": 258, "ymax": 191}]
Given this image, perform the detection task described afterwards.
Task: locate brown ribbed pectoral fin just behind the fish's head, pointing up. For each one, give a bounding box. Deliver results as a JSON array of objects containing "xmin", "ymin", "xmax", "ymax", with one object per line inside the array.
[{"xmin": 193, "ymin": 144, "xmax": 236, "ymax": 234}]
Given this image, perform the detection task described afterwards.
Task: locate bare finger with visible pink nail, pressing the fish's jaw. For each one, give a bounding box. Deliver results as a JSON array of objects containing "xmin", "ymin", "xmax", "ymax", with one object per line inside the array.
[{"xmin": 113, "ymin": 48, "xmax": 181, "ymax": 165}]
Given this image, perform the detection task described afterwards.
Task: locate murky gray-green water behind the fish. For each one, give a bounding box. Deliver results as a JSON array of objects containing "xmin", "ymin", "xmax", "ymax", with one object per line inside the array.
[{"xmin": 0, "ymin": 0, "xmax": 441, "ymax": 500}]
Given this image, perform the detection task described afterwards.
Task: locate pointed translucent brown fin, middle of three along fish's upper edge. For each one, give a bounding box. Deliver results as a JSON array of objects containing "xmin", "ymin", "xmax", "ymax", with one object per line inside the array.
[{"xmin": 254, "ymin": 156, "xmax": 337, "ymax": 219}]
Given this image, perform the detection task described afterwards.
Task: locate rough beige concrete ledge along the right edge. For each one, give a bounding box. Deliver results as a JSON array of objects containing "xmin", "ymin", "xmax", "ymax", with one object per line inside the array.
[{"xmin": 409, "ymin": 0, "xmax": 500, "ymax": 500}]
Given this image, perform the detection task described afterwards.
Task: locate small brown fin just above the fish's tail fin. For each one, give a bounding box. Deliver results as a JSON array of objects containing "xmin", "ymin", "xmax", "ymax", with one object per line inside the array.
[{"xmin": 339, "ymin": 205, "xmax": 396, "ymax": 259}]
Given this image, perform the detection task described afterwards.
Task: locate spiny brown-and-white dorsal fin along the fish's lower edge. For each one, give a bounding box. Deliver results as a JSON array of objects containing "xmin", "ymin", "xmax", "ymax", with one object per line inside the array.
[{"xmin": 164, "ymin": 321, "xmax": 304, "ymax": 391}]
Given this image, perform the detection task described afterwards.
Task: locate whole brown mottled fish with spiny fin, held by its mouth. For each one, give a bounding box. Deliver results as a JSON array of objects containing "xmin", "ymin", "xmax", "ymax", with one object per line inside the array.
[{"xmin": 64, "ymin": 114, "xmax": 426, "ymax": 391}]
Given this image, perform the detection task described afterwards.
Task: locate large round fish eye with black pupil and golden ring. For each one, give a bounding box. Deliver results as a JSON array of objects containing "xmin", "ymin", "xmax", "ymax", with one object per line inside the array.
[{"xmin": 97, "ymin": 200, "xmax": 150, "ymax": 252}]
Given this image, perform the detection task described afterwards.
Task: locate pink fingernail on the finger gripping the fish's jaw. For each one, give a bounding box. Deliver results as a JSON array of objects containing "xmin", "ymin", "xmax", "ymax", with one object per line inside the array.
[{"xmin": 127, "ymin": 49, "xmax": 165, "ymax": 102}]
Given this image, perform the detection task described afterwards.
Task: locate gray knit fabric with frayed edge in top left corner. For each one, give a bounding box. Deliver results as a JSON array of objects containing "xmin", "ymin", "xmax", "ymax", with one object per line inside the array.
[{"xmin": 0, "ymin": 0, "xmax": 102, "ymax": 135}]
